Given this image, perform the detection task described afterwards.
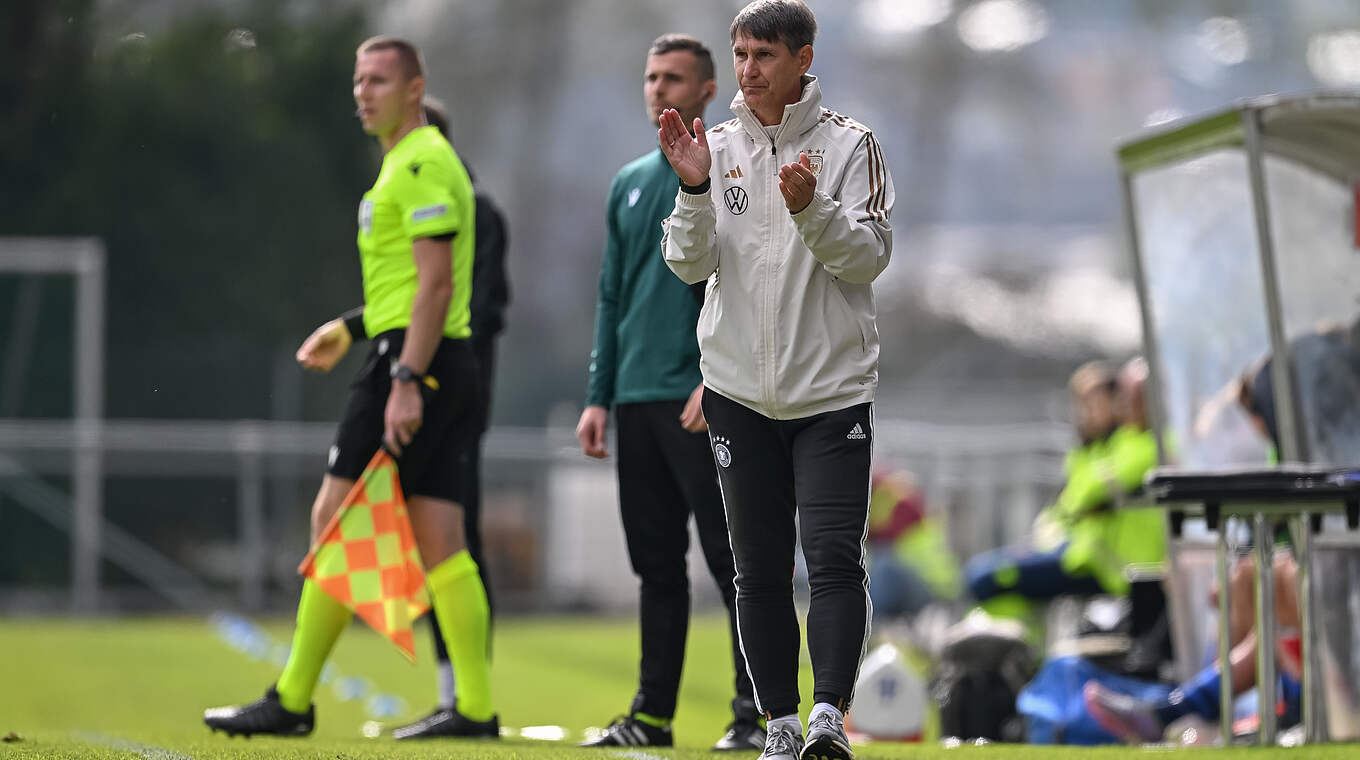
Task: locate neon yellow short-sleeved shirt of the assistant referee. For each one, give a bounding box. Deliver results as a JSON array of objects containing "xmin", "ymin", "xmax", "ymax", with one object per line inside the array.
[{"xmin": 359, "ymin": 126, "xmax": 476, "ymax": 339}]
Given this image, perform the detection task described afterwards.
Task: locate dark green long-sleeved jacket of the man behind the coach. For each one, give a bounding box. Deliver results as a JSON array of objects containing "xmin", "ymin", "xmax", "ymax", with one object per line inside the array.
[{"xmin": 586, "ymin": 148, "xmax": 703, "ymax": 408}]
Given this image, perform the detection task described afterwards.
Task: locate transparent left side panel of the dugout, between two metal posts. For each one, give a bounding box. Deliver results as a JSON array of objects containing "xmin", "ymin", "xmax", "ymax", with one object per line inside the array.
[{"xmin": 1132, "ymin": 150, "xmax": 1270, "ymax": 469}]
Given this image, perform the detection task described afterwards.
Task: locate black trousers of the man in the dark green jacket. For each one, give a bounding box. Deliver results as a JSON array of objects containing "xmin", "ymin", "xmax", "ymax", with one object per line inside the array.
[{"xmin": 615, "ymin": 401, "xmax": 755, "ymax": 719}]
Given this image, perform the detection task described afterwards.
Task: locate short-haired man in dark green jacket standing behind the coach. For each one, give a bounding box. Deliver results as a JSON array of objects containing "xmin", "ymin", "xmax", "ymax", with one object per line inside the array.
[{"xmin": 577, "ymin": 34, "xmax": 767, "ymax": 750}]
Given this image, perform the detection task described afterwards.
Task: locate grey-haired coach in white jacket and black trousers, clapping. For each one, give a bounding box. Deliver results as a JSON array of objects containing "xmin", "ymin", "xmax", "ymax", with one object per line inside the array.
[{"xmin": 658, "ymin": 0, "xmax": 894, "ymax": 760}]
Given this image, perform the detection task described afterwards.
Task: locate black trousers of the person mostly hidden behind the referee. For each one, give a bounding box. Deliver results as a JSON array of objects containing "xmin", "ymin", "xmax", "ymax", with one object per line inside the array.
[{"xmin": 430, "ymin": 339, "xmax": 496, "ymax": 662}]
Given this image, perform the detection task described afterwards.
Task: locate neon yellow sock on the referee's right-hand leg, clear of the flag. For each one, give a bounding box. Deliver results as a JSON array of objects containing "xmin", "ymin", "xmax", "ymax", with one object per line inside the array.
[{"xmin": 426, "ymin": 549, "xmax": 495, "ymax": 721}]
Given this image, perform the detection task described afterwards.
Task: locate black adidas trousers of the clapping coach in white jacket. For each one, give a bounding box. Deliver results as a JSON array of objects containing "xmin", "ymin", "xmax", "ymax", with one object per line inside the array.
[{"xmin": 703, "ymin": 389, "xmax": 873, "ymax": 718}]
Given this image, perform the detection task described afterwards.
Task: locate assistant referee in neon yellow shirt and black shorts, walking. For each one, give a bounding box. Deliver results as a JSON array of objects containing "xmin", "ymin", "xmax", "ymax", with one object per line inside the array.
[{"xmin": 204, "ymin": 37, "xmax": 499, "ymax": 738}]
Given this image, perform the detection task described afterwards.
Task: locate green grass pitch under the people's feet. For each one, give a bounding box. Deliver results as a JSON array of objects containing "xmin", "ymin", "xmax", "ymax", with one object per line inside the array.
[{"xmin": 0, "ymin": 616, "xmax": 1360, "ymax": 760}]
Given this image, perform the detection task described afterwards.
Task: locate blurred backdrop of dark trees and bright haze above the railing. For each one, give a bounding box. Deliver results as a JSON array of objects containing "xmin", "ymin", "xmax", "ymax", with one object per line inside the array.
[{"xmin": 0, "ymin": 0, "xmax": 1360, "ymax": 426}]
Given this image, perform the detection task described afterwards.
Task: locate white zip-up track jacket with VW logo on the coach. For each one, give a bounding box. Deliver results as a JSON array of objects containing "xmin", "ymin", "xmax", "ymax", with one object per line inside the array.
[{"xmin": 661, "ymin": 76, "xmax": 894, "ymax": 420}]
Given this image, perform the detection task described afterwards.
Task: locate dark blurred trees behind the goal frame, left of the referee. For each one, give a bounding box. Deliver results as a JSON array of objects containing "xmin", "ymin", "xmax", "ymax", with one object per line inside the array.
[{"xmin": 0, "ymin": 0, "xmax": 378, "ymax": 419}]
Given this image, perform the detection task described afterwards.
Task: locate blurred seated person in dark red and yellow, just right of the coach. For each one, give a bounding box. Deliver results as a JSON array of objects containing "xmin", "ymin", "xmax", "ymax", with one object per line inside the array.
[{"xmin": 868, "ymin": 469, "xmax": 960, "ymax": 619}]
